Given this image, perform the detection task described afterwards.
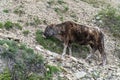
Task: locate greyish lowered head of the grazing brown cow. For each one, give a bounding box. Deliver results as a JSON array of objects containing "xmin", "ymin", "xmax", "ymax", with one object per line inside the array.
[{"xmin": 44, "ymin": 24, "xmax": 57, "ymax": 38}]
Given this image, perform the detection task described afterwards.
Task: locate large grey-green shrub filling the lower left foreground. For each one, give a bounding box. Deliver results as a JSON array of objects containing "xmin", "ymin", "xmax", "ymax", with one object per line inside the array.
[{"xmin": 0, "ymin": 40, "xmax": 59, "ymax": 80}]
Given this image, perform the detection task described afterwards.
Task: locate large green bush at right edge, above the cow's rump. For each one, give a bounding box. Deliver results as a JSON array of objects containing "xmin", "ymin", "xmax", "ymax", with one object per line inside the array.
[{"xmin": 95, "ymin": 6, "xmax": 120, "ymax": 38}]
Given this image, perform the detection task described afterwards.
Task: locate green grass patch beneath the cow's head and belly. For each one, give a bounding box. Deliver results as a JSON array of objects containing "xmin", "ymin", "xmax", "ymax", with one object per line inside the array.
[{"xmin": 36, "ymin": 30, "xmax": 89, "ymax": 58}]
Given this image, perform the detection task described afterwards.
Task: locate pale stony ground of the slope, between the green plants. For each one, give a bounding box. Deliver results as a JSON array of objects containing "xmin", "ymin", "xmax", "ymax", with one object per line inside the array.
[{"xmin": 0, "ymin": 0, "xmax": 120, "ymax": 80}]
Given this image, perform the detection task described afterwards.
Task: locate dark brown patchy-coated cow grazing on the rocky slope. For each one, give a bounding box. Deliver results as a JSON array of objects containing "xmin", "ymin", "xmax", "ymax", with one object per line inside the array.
[{"xmin": 43, "ymin": 21, "xmax": 106, "ymax": 65}]
